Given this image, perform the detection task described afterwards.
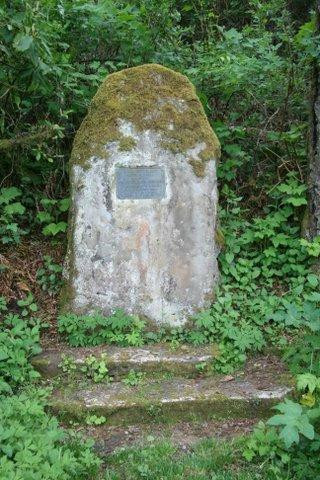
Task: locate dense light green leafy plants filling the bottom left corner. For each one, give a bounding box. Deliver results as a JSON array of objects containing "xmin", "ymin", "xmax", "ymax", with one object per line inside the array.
[{"xmin": 0, "ymin": 390, "xmax": 101, "ymax": 480}]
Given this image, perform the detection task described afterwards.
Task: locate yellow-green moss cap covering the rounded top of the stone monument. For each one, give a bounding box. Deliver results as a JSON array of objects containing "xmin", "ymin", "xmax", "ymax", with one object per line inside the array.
[{"xmin": 71, "ymin": 64, "xmax": 220, "ymax": 177}]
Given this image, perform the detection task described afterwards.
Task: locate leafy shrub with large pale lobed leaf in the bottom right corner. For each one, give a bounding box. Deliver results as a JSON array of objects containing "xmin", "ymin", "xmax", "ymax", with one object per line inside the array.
[{"xmin": 243, "ymin": 373, "xmax": 320, "ymax": 480}]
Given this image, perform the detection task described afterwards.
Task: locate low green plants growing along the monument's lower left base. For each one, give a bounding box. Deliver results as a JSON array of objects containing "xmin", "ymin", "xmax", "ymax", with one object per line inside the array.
[{"xmin": 58, "ymin": 310, "xmax": 145, "ymax": 347}]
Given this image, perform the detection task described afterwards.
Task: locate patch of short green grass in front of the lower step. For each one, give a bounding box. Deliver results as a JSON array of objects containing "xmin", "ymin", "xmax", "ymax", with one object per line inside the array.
[{"xmin": 105, "ymin": 438, "xmax": 268, "ymax": 480}]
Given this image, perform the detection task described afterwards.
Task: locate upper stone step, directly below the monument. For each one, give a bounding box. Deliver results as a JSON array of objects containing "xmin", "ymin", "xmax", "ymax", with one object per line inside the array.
[{"xmin": 32, "ymin": 344, "xmax": 217, "ymax": 380}]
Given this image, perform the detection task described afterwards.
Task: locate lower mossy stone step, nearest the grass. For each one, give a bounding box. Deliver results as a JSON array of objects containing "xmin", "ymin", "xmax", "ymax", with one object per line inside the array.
[{"xmin": 50, "ymin": 358, "xmax": 291, "ymax": 425}]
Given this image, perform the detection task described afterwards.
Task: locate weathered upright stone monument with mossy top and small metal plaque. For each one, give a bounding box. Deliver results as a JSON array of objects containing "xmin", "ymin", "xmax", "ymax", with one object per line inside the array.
[{"xmin": 63, "ymin": 65, "xmax": 219, "ymax": 325}]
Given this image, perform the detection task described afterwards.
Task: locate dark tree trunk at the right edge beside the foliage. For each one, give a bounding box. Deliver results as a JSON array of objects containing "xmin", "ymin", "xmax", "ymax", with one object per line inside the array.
[{"xmin": 308, "ymin": 0, "xmax": 320, "ymax": 240}]
